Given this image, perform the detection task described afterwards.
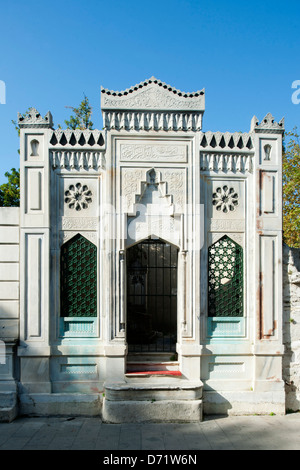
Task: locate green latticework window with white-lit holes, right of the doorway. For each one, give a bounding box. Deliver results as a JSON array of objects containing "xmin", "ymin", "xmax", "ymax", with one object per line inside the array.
[{"xmin": 208, "ymin": 235, "xmax": 244, "ymax": 317}]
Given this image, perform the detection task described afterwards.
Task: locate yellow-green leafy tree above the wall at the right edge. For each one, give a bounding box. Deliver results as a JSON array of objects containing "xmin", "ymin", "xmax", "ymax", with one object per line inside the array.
[{"xmin": 282, "ymin": 129, "xmax": 300, "ymax": 248}]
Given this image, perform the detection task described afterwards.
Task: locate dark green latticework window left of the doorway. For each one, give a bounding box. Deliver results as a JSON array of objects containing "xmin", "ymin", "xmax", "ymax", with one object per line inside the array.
[{"xmin": 60, "ymin": 234, "xmax": 97, "ymax": 317}]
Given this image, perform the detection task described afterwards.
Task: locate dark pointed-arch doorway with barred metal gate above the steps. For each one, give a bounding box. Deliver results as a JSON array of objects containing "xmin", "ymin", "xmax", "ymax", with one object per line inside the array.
[{"xmin": 127, "ymin": 239, "xmax": 178, "ymax": 353}]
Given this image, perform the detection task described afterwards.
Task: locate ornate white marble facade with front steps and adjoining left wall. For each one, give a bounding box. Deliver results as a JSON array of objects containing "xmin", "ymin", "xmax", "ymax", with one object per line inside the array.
[{"xmin": 0, "ymin": 77, "xmax": 294, "ymax": 422}]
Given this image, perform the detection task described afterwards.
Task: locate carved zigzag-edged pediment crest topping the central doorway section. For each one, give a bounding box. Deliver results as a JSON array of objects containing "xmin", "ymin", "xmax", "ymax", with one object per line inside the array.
[{"xmin": 101, "ymin": 77, "xmax": 205, "ymax": 112}]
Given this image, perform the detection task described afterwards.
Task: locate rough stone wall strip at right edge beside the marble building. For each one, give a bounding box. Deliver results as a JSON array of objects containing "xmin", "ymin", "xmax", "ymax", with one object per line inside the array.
[{"xmin": 283, "ymin": 244, "xmax": 300, "ymax": 411}]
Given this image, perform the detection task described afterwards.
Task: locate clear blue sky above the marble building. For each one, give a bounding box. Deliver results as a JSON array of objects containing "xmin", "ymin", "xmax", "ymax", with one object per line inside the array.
[{"xmin": 0, "ymin": 0, "xmax": 300, "ymax": 184}]
